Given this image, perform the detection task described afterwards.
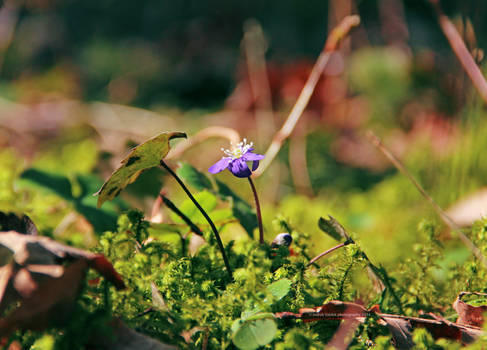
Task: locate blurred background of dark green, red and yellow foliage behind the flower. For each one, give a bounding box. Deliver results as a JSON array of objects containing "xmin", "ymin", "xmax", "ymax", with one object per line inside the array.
[{"xmin": 0, "ymin": 0, "xmax": 487, "ymax": 265}]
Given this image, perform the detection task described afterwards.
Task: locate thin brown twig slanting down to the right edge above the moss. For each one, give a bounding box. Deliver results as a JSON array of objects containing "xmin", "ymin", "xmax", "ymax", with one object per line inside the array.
[{"xmin": 368, "ymin": 131, "xmax": 487, "ymax": 267}]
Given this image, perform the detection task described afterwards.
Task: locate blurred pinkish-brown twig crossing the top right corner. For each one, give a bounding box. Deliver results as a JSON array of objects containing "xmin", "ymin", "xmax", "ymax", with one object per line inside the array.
[{"xmin": 429, "ymin": 0, "xmax": 487, "ymax": 103}]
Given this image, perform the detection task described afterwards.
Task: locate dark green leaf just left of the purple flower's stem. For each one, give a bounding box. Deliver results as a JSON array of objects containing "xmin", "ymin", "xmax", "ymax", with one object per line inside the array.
[{"xmin": 216, "ymin": 180, "xmax": 258, "ymax": 238}]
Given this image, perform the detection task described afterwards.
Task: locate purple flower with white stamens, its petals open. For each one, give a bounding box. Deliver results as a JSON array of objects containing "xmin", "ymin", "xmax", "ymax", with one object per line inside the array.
[{"xmin": 208, "ymin": 139, "xmax": 264, "ymax": 177}]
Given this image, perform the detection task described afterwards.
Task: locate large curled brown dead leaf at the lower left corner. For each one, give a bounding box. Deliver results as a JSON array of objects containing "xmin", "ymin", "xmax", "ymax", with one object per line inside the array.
[{"xmin": 0, "ymin": 231, "xmax": 125, "ymax": 336}]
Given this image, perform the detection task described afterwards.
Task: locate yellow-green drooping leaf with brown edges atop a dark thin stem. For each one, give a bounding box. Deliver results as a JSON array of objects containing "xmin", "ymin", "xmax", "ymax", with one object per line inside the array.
[{"xmin": 94, "ymin": 132, "xmax": 186, "ymax": 208}]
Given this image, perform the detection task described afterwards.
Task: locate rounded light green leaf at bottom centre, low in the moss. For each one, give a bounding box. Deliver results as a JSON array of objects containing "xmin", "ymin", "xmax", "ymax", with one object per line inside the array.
[{"xmin": 232, "ymin": 319, "xmax": 277, "ymax": 350}]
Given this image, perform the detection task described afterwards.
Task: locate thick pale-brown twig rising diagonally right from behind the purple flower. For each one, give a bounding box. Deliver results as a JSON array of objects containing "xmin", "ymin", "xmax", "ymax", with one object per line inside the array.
[{"xmin": 254, "ymin": 16, "xmax": 360, "ymax": 177}]
